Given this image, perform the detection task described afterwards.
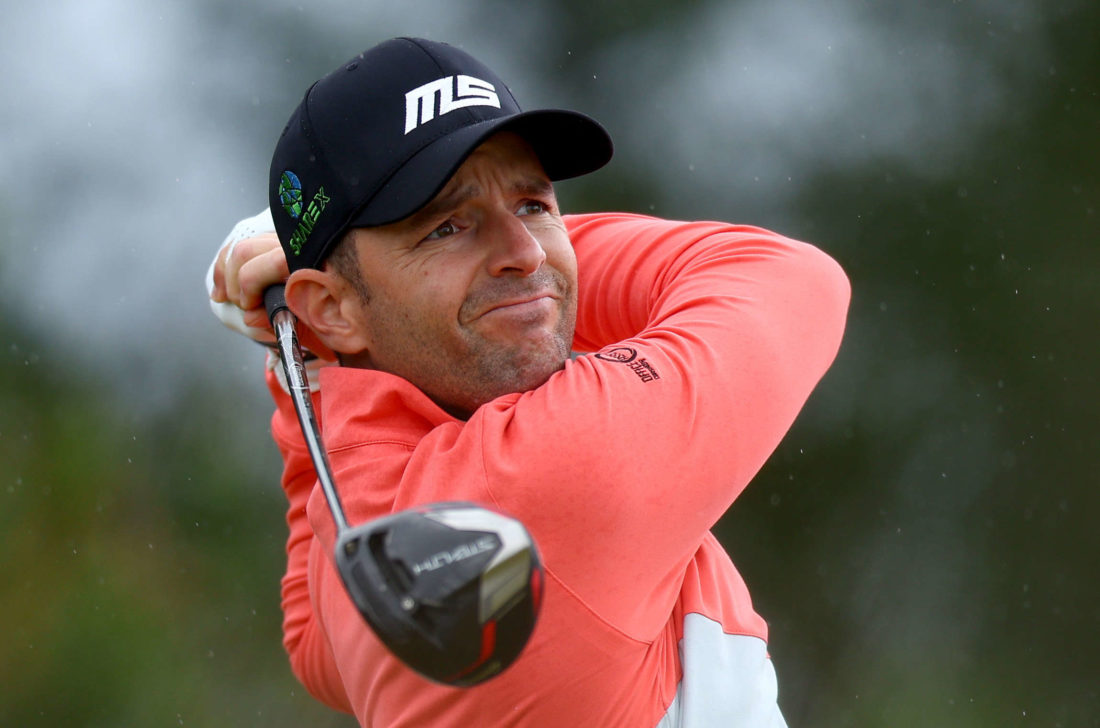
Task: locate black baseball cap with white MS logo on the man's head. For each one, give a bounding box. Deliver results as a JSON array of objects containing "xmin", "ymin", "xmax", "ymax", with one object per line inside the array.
[{"xmin": 268, "ymin": 37, "xmax": 612, "ymax": 271}]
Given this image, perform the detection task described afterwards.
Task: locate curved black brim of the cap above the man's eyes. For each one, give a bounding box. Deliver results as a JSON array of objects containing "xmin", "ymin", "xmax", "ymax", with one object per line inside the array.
[{"xmin": 347, "ymin": 109, "xmax": 614, "ymax": 228}]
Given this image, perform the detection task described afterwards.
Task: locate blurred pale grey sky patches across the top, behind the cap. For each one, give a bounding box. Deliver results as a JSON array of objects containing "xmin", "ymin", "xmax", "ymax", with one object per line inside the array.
[{"xmin": 0, "ymin": 0, "xmax": 1054, "ymax": 411}]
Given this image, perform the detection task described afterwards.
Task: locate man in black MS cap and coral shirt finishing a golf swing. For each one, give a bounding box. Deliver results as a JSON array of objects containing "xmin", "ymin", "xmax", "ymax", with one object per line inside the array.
[{"xmin": 210, "ymin": 38, "xmax": 848, "ymax": 727}]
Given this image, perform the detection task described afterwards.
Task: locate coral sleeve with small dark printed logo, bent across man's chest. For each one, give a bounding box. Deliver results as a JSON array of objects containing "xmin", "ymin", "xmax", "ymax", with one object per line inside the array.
[{"xmin": 466, "ymin": 214, "xmax": 849, "ymax": 639}]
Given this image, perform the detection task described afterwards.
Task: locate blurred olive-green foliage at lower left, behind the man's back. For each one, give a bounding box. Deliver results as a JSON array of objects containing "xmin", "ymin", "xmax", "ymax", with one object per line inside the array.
[{"xmin": 0, "ymin": 317, "xmax": 345, "ymax": 726}]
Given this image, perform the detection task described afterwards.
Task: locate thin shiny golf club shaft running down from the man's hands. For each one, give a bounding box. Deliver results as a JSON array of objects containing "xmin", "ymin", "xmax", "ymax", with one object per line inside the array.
[{"xmin": 264, "ymin": 285, "xmax": 348, "ymax": 533}]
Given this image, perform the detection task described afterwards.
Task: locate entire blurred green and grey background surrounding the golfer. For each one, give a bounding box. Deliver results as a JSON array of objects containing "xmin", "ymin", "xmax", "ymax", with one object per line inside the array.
[{"xmin": 0, "ymin": 0, "xmax": 1100, "ymax": 728}]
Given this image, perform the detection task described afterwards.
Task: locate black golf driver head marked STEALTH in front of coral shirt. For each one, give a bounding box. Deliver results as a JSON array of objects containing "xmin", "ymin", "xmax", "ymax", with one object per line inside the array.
[{"xmin": 336, "ymin": 503, "xmax": 542, "ymax": 687}]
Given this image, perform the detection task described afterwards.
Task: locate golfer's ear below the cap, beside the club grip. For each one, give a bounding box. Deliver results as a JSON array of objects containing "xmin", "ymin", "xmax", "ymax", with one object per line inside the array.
[{"xmin": 286, "ymin": 268, "xmax": 366, "ymax": 354}]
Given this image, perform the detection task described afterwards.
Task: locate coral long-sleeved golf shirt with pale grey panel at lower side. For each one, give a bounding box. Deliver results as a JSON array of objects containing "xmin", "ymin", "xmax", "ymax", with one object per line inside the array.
[{"xmin": 270, "ymin": 214, "xmax": 849, "ymax": 728}]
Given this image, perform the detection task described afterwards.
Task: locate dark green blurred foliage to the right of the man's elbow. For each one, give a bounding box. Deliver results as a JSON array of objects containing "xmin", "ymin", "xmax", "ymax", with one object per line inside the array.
[{"xmin": 721, "ymin": 4, "xmax": 1100, "ymax": 727}]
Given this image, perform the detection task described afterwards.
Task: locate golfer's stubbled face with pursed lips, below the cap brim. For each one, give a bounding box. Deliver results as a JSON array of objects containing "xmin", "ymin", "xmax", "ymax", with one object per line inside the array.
[{"xmin": 341, "ymin": 133, "xmax": 576, "ymax": 417}]
